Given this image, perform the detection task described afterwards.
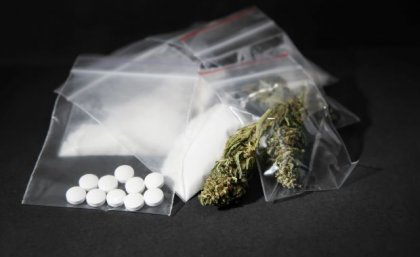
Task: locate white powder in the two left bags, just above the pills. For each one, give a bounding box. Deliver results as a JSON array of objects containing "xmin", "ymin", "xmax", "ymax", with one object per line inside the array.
[{"xmin": 59, "ymin": 94, "xmax": 187, "ymax": 157}]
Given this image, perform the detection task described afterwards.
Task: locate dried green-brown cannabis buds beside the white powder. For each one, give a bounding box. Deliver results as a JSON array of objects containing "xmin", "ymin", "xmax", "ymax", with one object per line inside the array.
[{"xmin": 198, "ymin": 97, "xmax": 305, "ymax": 206}]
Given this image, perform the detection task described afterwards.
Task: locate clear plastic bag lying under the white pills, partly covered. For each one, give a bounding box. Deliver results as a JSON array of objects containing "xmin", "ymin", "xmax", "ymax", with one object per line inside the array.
[{"xmin": 22, "ymin": 96, "xmax": 174, "ymax": 215}]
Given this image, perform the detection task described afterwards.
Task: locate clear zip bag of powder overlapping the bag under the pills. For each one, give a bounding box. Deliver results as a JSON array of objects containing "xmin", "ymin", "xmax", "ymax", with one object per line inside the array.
[{"xmin": 58, "ymin": 51, "xmax": 197, "ymax": 178}]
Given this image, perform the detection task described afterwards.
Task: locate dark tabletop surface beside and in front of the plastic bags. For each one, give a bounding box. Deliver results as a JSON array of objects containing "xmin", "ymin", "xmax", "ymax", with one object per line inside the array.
[{"xmin": 0, "ymin": 48, "xmax": 420, "ymax": 256}]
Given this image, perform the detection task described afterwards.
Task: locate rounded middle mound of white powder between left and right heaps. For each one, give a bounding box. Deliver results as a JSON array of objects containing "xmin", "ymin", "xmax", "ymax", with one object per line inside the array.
[{"xmin": 103, "ymin": 90, "xmax": 188, "ymax": 158}]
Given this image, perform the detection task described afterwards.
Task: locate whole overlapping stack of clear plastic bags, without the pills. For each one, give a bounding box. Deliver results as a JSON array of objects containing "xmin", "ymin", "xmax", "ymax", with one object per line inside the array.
[{"xmin": 23, "ymin": 8, "xmax": 358, "ymax": 215}]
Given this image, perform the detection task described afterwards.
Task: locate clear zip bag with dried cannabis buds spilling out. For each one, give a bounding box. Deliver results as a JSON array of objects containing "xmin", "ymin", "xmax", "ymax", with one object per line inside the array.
[{"xmin": 200, "ymin": 56, "xmax": 356, "ymax": 202}]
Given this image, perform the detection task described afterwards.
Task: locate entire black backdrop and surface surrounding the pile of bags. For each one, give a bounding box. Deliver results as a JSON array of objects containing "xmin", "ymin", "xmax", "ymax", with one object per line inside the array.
[{"xmin": 0, "ymin": 0, "xmax": 420, "ymax": 256}]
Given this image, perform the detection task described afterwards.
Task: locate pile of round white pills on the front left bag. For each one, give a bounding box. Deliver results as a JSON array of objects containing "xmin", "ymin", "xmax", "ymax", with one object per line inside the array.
[{"xmin": 66, "ymin": 165, "xmax": 164, "ymax": 211}]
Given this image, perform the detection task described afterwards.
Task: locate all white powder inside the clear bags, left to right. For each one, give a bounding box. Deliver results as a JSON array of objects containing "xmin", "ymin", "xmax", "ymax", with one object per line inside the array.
[{"xmin": 61, "ymin": 74, "xmax": 249, "ymax": 201}]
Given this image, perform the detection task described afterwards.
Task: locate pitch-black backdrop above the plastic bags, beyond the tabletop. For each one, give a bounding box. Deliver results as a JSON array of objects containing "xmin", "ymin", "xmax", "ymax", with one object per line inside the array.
[{"xmin": 0, "ymin": 0, "xmax": 420, "ymax": 63}]
